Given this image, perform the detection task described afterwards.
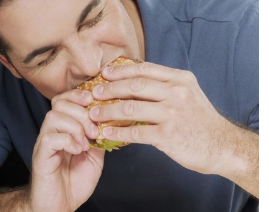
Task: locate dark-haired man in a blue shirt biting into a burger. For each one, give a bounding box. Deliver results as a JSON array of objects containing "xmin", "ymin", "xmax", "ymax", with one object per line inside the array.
[{"xmin": 0, "ymin": 0, "xmax": 259, "ymax": 212}]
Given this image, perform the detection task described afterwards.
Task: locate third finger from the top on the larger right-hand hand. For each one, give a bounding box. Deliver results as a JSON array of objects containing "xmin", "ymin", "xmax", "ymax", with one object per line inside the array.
[{"xmin": 90, "ymin": 100, "xmax": 164, "ymax": 124}]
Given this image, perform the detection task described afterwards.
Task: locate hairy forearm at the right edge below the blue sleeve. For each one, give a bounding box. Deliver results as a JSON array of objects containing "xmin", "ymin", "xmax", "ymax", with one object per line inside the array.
[{"xmin": 216, "ymin": 118, "xmax": 259, "ymax": 198}]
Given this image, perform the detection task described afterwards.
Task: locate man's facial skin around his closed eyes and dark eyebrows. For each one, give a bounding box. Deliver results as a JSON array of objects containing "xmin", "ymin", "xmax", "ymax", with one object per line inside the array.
[{"xmin": 0, "ymin": 0, "xmax": 144, "ymax": 98}]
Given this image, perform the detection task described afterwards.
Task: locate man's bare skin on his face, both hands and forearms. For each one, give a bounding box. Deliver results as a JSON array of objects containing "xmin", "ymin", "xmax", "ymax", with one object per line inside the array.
[{"xmin": 0, "ymin": 0, "xmax": 259, "ymax": 211}]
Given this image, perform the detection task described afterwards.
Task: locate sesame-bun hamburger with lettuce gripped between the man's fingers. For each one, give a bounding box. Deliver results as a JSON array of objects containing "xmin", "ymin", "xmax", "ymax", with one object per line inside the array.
[{"xmin": 77, "ymin": 57, "xmax": 143, "ymax": 152}]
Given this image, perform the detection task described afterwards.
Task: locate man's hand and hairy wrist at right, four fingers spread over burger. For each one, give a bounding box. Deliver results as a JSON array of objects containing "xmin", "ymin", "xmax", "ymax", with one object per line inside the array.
[{"xmin": 90, "ymin": 63, "xmax": 258, "ymax": 196}]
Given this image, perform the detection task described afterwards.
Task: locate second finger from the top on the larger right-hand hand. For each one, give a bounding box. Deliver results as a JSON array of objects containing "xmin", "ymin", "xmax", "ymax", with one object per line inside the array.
[{"xmin": 93, "ymin": 78, "xmax": 168, "ymax": 101}]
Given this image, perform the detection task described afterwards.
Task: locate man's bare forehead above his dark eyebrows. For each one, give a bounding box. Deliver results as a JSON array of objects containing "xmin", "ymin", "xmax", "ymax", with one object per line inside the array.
[{"xmin": 0, "ymin": 0, "xmax": 96, "ymax": 54}]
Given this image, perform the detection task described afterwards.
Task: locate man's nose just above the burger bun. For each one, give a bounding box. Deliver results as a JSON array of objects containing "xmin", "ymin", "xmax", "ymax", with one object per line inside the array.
[{"xmin": 68, "ymin": 37, "xmax": 103, "ymax": 79}]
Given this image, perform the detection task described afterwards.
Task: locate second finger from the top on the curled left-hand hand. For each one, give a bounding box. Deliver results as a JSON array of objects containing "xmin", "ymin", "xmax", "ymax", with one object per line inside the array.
[{"xmin": 53, "ymin": 99, "xmax": 99, "ymax": 139}]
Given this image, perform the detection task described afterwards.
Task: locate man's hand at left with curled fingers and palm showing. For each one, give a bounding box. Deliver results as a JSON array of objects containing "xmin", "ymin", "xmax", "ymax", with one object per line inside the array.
[{"xmin": 29, "ymin": 90, "xmax": 104, "ymax": 212}]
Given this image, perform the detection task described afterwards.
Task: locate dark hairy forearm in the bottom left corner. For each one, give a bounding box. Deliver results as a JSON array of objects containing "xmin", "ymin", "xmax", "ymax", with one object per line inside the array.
[{"xmin": 0, "ymin": 187, "xmax": 30, "ymax": 212}]
